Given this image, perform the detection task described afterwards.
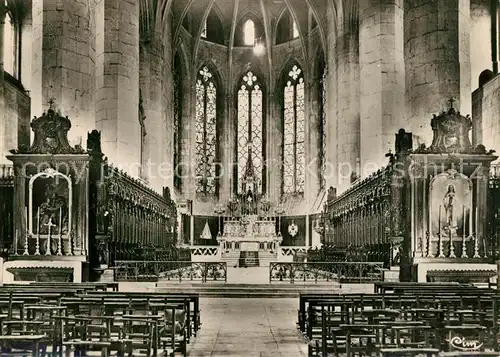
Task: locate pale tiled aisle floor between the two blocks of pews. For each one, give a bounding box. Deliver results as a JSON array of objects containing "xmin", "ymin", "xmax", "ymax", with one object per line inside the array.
[{"xmin": 188, "ymin": 298, "xmax": 307, "ymax": 357}]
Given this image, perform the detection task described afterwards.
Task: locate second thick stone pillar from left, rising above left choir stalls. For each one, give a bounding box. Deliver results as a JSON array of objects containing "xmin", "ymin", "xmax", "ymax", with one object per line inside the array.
[{"xmin": 95, "ymin": 0, "xmax": 141, "ymax": 177}]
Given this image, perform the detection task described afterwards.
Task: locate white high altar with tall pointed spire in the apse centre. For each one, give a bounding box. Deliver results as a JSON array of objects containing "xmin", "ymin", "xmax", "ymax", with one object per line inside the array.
[{"xmin": 217, "ymin": 156, "xmax": 283, "ymax": 253}]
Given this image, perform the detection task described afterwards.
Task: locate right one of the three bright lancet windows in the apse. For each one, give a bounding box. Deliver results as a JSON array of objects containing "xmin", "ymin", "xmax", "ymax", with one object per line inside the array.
[{"xmin": 283, "ymin": 65, "xmax": 305, "ymax": 194}]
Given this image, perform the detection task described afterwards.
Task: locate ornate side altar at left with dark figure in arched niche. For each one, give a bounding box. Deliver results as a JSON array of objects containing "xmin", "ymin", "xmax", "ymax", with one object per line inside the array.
[{"xmin": 5, "ymin": 103, "xmax": 90, "ymax": 281}]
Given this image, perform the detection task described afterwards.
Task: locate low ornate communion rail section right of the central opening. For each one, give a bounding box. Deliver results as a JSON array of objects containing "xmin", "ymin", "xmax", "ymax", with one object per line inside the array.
[{"xmin": 269, "ymin": 262, "xmax": 384, "ymax": 284}]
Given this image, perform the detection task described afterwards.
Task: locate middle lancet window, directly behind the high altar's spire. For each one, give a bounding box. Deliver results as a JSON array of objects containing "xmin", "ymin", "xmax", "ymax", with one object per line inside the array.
[{"xmin": 236, "ymin": 71, "xmax": 264, "ymax": 193}]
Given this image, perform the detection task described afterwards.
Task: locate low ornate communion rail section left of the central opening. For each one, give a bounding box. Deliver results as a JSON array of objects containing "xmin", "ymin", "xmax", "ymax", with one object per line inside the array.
[{"xmin": 113, "ymin": 260, "xmax": 227, "ymax": 283}]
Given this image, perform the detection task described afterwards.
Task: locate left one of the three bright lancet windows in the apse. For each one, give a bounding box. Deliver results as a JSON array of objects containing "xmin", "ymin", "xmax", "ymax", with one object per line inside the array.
[{"xmin": 195, "ymin": 66, "xmax": 217, "ymax": 194}]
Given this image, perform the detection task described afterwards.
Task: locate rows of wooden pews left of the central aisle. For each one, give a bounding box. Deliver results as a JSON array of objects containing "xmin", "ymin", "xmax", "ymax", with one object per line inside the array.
[{"xmin": 0, "ymin": 283, "xmax": 201, "ymax": 357}]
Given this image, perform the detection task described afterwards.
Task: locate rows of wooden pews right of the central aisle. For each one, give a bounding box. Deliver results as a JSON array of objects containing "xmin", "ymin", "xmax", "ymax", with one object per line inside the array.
[{"xmin": 298, "ymin": 283, "xmax": 500, "ymax": 357}]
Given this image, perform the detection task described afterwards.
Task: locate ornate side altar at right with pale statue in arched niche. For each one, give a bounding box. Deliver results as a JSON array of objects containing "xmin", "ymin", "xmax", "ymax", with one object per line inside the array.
[{"xmin": 408, "ymin": 101, "xmax": 498, "ymax": 281}]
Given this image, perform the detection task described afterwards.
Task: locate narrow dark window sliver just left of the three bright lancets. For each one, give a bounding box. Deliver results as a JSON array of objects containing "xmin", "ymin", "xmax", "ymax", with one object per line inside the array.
[{"xmin": 173, "ymin": 56, "xmax": 182, "ymax": 189}]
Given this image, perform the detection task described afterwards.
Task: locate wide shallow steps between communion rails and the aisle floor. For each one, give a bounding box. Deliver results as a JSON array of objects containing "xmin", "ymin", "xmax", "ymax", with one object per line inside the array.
[{"xmin": 154, "ymin": 282, "xmax": 345, "ymax": 298}]
